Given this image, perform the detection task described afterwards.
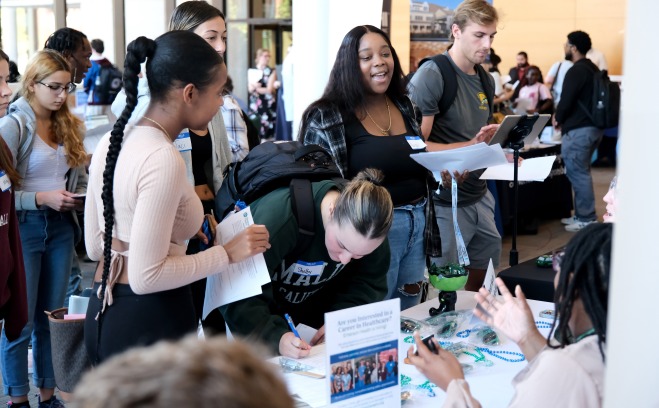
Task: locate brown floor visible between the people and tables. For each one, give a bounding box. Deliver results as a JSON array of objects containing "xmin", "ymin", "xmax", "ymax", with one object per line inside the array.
[{"xmin": 0, "ymin": 168, "xmax": 615, "ymax": 407}]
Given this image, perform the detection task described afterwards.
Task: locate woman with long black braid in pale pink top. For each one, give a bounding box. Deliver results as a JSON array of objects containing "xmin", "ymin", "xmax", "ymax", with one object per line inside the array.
[{"xmin": 85, "ymin": 31, "xmax": 270, "ymax": 363}]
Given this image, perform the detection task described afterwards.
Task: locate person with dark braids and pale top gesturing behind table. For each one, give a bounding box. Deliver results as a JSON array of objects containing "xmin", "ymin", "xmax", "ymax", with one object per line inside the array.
[{"xmin": 408, "ymin": 223, "xmax": 613, "ymax": 408}]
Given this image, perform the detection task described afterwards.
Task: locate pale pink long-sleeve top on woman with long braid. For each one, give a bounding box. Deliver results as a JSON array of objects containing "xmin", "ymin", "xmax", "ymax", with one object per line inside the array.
[{"xmin": 85, "ymin": 126, "xmax": 229, "ymax": 294}]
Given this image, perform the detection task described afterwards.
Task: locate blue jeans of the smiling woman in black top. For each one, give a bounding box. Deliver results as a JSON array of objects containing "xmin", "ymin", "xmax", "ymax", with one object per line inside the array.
[{"xmin": 386, "ymin": 199, "xmax": 426, "ymax": 310}]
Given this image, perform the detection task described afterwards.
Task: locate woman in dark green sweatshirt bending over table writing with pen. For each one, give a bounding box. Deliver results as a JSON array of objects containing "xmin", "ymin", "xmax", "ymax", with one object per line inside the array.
[{"xmin": 220, "ymin": 169, "xmax": 393, "ymax": 358}]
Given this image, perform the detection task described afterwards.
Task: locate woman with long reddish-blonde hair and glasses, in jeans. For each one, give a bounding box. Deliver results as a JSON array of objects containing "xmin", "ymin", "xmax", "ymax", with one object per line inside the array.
[{"xmin": 0, "ymin": 50, "xmax": 87, "ymax": 407}]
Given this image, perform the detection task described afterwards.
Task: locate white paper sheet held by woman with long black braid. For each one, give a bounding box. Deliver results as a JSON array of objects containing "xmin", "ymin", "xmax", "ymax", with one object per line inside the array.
[{"xmin": 203, "ymin": 207, "xmax": 270, "ymax": 318}]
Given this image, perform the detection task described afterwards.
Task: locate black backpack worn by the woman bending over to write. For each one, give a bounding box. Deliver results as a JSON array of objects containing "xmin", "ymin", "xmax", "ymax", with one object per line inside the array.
[{"xmin": 215, "ymin": 141, "xmax": 344, "ymax": 256}]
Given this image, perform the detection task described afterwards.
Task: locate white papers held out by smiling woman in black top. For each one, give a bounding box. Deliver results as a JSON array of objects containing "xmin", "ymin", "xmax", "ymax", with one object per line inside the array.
[{"xmin": 410, "ymin": 143, "xmax": 508, "ymax": 181}]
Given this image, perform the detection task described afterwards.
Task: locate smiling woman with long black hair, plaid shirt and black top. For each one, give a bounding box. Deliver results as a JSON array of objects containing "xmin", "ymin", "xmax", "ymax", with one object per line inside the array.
[{"xmin": 299, "ymin": 25, "xmax": 441, "ymax": 309}]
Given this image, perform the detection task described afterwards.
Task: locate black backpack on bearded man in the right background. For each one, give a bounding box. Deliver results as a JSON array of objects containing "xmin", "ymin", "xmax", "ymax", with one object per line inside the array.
[{"xmin": 579, "ymin": 69, "xmax": 620, "ymax": 129}]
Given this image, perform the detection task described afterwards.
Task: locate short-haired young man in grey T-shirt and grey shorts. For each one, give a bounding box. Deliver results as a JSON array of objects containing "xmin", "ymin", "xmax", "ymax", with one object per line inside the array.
[{"xmin": 410, "ymin": 0, "xmax": 501, "ymax": 290}]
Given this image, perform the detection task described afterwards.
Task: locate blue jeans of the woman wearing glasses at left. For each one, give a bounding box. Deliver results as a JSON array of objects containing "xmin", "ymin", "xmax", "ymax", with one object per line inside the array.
[{"xmin": 0, "ymin": 209, "xmax": 74, "ymax": 397}]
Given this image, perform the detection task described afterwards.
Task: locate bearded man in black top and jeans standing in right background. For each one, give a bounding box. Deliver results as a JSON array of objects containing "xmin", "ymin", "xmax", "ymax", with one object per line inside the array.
[{"xmin": 554, "ymin": 31, "xmax": 604, "ymax": 232}]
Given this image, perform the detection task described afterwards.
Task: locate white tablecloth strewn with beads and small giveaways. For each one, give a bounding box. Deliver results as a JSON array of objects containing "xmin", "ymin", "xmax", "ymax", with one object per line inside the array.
[{"xmin": 284, "ymin": 291, "xmax": 554, "ymax": 408}]
